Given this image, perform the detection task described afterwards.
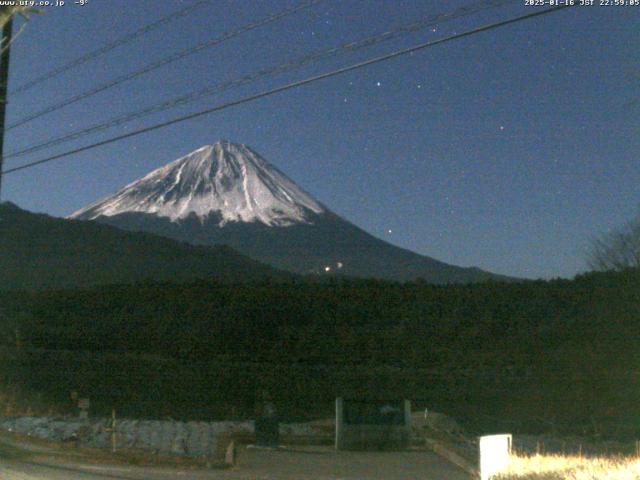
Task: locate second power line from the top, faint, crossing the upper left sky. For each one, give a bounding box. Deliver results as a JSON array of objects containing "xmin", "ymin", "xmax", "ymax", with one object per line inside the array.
[{"xmin": 5, "ymin": 0, "xmax": 324, "ymax": 131}]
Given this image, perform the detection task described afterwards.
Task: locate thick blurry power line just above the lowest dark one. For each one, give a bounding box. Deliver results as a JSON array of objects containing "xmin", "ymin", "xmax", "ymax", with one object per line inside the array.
[{"xmin": 5, "ymin": 0, "xmax": 511, "ymax": 162}]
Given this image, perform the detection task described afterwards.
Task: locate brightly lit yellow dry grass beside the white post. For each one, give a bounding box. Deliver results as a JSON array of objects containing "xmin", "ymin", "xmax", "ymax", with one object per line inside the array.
[{"xmin": 494, "ymin": 455, "xmax": 640, "ymax": 480}]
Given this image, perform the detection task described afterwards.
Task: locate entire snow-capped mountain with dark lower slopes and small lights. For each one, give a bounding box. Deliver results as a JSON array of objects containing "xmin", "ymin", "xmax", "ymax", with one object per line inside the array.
[{"xmin": 70, "ymin": 141, "xmax": 506, "ymax": 283}]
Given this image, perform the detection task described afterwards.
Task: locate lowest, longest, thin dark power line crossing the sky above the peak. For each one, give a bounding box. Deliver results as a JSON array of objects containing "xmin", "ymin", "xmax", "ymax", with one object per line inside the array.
[{"xmin": 4, "ymin": 5, "xmax": 573, "ymax": 175}]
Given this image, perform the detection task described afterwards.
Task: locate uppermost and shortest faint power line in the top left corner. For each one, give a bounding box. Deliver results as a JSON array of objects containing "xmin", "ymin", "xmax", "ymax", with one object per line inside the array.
[{"xmin": 10, "ymin": 0, "xmax": 211, "ymax": 95}]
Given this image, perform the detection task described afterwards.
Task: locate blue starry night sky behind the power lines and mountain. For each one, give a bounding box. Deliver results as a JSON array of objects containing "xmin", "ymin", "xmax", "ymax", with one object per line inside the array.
[{"xmin": 3, "ymin": 0, "xmax": 640, "ymax": 278}]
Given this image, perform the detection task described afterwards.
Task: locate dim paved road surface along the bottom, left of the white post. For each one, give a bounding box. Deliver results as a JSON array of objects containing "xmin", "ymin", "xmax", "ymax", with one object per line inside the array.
[{"xmin": 0, "ymin": 447, "xmax": 469, "ymax": 480}]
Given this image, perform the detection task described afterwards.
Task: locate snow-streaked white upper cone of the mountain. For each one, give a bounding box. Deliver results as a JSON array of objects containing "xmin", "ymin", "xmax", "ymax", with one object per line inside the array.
[{"xmin": 70, "ymin": 140, "xmax": 325, "ymax": 226}]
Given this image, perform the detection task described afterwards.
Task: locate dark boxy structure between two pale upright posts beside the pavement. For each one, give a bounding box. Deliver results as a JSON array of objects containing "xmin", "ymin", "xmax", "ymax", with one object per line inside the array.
[{"xmin": 335, "ymin": 397, "xmax": 411, "ymax": 450}]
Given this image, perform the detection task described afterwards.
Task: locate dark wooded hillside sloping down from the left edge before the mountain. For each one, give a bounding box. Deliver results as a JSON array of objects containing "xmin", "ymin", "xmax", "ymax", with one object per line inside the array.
[{"xmin": 0, "ymin": 203, "xmax": 288, "ymax": 290}]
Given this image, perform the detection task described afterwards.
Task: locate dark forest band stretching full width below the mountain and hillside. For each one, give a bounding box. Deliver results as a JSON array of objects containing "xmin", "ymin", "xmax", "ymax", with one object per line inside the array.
[{"xmin": 0, "ymin": 269, "xmax": 640, "ymax": 431}]
